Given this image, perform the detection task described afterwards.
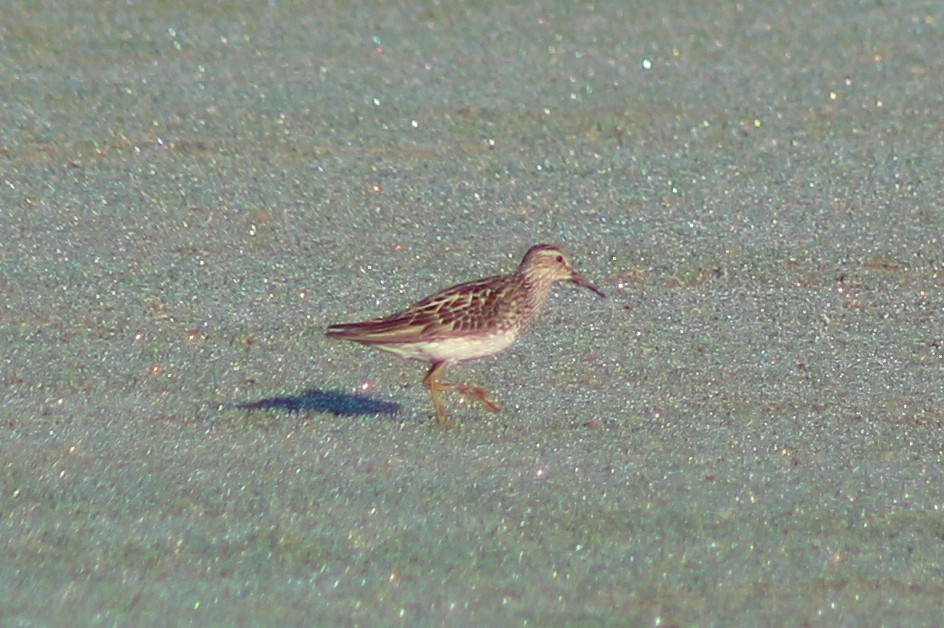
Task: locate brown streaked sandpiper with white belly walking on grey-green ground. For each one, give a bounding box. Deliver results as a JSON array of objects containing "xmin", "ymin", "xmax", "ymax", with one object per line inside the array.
[{"xmin": 325, "ymin": 244, "xmax": 606, "ymax": 425}]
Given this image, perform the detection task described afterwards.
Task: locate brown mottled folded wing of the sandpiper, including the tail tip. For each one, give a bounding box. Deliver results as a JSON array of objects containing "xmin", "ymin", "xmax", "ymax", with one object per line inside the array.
[{"xmin": 328, "ymin": 277, "xmax": 526, "ymax": 344}]
